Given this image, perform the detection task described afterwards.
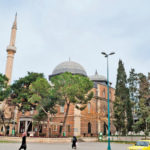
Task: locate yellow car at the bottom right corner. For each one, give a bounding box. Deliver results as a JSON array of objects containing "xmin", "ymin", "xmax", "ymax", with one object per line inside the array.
[{"xmin": 128, "ymin": 140, "xmax": 150, "ymax": 150}]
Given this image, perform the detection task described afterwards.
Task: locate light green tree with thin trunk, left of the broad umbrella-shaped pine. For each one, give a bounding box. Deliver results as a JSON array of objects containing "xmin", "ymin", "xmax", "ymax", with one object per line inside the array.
[{"xmin": 29, "ymin": 78, "xmax": 57, "ymax": 137}]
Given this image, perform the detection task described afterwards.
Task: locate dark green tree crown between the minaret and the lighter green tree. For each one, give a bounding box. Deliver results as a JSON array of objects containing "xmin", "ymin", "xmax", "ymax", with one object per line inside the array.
[{"xmin": 11, "ymin": 72, "xmax": 43, "ymax": 111}]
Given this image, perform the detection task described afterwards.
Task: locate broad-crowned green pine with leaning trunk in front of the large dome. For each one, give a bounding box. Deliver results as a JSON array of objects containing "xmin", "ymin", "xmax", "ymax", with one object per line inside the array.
[{"xmin": 51, "ymin": 72, "xmax": 93, "ymax": 135}]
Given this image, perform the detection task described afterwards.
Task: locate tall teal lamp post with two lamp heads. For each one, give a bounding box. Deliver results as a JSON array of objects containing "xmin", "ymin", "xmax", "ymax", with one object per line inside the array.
[{"xmin": 101, "ymin": 52, "xmax": 115, "ymax": 150}]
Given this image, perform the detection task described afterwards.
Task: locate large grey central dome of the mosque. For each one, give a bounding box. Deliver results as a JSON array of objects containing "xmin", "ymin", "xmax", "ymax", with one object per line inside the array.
[{"xmin": 51, "ymin": 61, "xmax": 87, "ymax": 76}]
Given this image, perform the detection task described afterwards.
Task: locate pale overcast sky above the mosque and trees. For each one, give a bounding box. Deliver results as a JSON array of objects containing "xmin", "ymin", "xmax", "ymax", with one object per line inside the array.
[{"xmin": 0, "ymin": 0, "xmax": 150, "ymax": 86}]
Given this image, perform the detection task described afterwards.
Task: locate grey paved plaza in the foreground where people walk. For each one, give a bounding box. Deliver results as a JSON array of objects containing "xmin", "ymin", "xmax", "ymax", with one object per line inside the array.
[{"xmin": 0, "ymin": 142, "xmax": 130, "ymax": 150}]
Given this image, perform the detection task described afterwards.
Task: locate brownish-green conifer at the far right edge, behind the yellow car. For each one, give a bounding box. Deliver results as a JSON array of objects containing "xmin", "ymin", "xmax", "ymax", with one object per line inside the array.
[{"xmin": 134, "ymin": 73, "xmax": 150, "ymax": 135}]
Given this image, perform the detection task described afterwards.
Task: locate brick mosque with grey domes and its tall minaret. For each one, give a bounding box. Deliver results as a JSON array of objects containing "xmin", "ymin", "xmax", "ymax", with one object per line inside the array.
[{"xmin": 0, "ymin": 15, "xmax": 115, "ymax": 137}]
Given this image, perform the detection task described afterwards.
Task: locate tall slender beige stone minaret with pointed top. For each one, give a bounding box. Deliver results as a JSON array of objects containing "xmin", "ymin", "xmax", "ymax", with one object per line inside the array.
[{"xmin": 5, "ymin": 13, "xmax": 17, "ymax": 85}]
